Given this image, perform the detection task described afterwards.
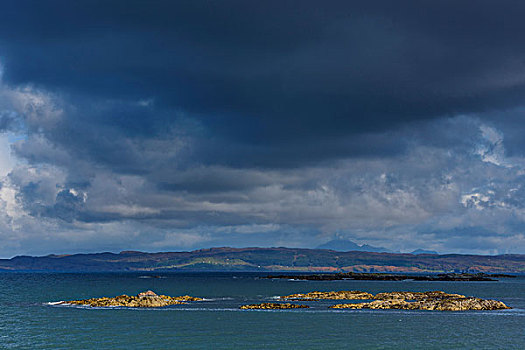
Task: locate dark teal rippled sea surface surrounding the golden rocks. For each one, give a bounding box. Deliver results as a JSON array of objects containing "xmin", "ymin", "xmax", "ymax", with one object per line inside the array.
[{"xmin": 0, "ymin": 273, "xmax": 525, "ymax": 349}]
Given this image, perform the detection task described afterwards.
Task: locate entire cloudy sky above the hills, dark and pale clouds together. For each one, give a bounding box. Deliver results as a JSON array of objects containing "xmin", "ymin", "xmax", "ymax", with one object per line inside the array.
[{"xmin": 0, "ymin": 0, "xmax": 525, "ymax": 257}]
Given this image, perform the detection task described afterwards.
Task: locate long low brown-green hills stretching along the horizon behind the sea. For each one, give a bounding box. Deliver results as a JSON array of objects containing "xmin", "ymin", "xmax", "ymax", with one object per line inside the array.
[{"xmin": 0, "ymin": 247, "xmax": 525, "ymax": 273}]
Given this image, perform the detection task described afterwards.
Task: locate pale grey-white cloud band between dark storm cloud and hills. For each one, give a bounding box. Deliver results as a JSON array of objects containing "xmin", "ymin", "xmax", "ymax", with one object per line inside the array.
[{"xmin": 0, "ymin": 83, "xmax": 525, "ymax": 254}]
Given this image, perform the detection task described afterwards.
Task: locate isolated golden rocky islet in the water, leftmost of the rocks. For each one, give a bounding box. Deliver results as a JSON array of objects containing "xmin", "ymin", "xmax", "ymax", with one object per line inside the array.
[{"xmin": 63, "ymin": 291, "xmax": 203, "ymax": 307}]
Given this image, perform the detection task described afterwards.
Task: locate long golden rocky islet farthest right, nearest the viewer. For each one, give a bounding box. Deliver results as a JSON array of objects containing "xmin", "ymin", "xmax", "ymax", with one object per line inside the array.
[{"xmin": 330, "ymin": 297, "xmax": 510, "ymax": 311}]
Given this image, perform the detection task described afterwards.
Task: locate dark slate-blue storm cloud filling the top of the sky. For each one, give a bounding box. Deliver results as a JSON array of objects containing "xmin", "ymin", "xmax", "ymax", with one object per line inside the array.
[{"xmin": 0, "ymin": 1, "xmax": 525, "ymax": 166}]
